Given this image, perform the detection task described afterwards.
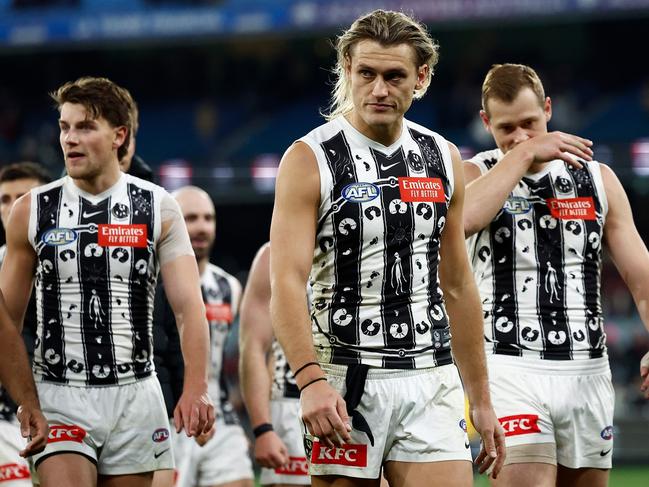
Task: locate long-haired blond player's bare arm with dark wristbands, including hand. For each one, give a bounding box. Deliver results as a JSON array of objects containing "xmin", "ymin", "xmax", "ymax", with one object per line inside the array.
[{"xmin": 270, "ymin": 142, "xmax": 351, "ymax": 447}]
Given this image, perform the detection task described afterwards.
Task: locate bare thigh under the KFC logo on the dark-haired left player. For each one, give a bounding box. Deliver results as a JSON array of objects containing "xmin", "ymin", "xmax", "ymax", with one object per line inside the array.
[{"xmin": 36, "ymin": 453, "xmax": 97, "ymax": 487}]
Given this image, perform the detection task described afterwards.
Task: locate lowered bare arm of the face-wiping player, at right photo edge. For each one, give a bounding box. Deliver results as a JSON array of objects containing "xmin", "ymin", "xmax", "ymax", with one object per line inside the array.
[{"xmin": 600, "ymin": 164, "xmax": 649, "ymax": 399}]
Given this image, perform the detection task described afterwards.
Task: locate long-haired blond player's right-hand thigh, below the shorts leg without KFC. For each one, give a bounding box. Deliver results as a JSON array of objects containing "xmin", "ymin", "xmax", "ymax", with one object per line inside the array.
[{"xmin": 383, "ymin": 460, "xmax": 473, "ymax": 487}]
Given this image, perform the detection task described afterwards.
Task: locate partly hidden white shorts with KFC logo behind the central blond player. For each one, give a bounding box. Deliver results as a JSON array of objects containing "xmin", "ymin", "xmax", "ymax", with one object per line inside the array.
[{"xmin": 260, "ymin": 398, "xmax": 311, "ymax": 485}]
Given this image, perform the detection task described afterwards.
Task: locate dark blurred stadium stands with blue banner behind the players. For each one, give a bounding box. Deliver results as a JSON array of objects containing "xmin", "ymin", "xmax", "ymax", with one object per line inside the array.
[{"xmin": 0, "ymin": 0, "xmax": 649, "ymax": 486}]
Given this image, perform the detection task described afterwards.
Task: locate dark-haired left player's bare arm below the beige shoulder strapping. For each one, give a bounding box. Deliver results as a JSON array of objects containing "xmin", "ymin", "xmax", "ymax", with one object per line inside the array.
[{"xmin": 160, "ymin": 238, "xmax": 214, "ymax": 436}]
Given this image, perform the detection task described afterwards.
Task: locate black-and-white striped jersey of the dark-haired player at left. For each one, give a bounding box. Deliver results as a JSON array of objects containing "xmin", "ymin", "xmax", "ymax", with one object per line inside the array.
[{"xmin": 29, "ymin": 175, "xmax": 171, "ymax": 386}]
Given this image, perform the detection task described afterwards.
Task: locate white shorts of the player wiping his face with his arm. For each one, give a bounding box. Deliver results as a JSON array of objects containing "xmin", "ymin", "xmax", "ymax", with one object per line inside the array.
[{"xmin": 489, "ymin": 357, "xmax": 615, "ymax": 469}]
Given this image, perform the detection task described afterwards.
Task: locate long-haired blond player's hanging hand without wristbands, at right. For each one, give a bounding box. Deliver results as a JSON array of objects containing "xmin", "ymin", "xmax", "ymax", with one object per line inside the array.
[{"xmin": 471, "ymin": 407, "xmax": 506, "ymax": 479}]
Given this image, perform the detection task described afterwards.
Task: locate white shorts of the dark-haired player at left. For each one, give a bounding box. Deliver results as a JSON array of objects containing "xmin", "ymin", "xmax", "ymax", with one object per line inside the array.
[{"xmin": 34, "ymin": 377, "xmax": 174, "ymax": 475}]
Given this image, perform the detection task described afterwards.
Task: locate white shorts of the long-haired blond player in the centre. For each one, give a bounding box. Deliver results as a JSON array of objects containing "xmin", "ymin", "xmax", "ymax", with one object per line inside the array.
[{"xmin": 300, "ymin": 364, "xmax": 471, "ymax": 479}]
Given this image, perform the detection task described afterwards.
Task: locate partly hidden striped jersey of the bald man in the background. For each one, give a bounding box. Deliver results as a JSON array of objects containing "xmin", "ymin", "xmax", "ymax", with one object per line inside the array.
[{"xmin": 201, "ymin": 263, "xmax": 241, "ymax": 423}]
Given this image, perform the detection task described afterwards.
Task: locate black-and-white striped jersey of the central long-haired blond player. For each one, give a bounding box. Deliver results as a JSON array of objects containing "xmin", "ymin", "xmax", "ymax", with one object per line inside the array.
[{"xmin": 300, "ymin": 117, "xmax": 453, "ymax": 369}]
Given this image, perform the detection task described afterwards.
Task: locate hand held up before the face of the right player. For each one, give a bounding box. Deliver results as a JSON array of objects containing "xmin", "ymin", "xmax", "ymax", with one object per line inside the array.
[{"xmin": 514, "ymin": 132, "xmax": 593, "ymax": 169}]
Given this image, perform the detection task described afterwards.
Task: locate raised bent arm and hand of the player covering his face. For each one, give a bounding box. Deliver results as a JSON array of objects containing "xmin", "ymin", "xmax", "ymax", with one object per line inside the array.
[{"xmin": 464, "ymin": 132, "xmax": 592, "ymax": 237}]
